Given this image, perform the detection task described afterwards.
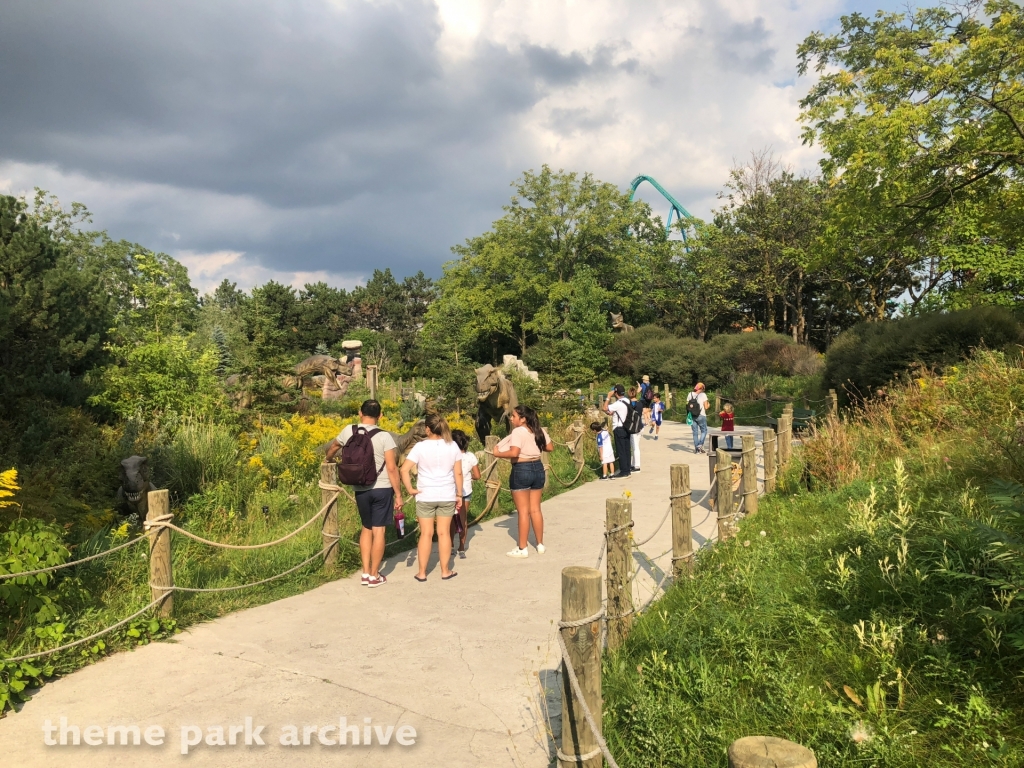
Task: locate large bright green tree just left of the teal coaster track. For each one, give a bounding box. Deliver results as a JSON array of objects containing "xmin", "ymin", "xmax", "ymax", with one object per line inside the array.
[{"xmin": 439, "ymin": 166, "xmax": 668, "ymax": 358}]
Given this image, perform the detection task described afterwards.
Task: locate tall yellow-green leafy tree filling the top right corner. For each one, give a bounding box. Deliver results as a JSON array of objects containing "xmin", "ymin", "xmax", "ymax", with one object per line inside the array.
[{"xmin": 798, "ymin": 0, "xmax": 1024, "ymax": 319}]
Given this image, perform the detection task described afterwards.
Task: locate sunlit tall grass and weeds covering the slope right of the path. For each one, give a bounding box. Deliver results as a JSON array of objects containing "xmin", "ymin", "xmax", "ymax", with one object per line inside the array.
[{"xmin": 605, "ymin": 353, "xmax": 1024, "ymax": 768}]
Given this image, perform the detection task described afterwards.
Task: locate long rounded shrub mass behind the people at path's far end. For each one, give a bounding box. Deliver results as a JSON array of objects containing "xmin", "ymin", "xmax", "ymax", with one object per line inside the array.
[{"xmin": 608, "ymin": 326, "xmax": 820, "ymax": 389}]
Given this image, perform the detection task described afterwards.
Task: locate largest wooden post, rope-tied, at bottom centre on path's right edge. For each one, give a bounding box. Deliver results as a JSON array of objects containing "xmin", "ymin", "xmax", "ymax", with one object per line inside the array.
[{"xmin": 558, "ymin": 565, "xmax": 604, "ymax": 768}]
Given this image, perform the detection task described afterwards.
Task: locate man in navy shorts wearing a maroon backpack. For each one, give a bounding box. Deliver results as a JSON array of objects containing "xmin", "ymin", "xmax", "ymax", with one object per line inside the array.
[{"xmin": 327, "ymin": 400, "xmax": 402, "ymax": 587}]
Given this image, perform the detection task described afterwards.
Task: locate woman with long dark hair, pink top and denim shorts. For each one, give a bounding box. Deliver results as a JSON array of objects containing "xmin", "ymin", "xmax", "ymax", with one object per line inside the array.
[{"xmin": 495, "ymin": 406, "xmax": 555, "ymax": 557}]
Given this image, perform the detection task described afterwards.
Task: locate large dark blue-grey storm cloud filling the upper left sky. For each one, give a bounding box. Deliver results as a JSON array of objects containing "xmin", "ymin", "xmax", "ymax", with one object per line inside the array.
[{"xmin": 0, "ymin": 0, "xmax": 611, "ymax": 272}]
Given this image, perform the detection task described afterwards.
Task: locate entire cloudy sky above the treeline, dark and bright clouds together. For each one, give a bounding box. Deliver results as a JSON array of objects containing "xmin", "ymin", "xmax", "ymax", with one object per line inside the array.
[{"xmin": 0, "ymin": 0, "xmax": 897, "ymax": 291}]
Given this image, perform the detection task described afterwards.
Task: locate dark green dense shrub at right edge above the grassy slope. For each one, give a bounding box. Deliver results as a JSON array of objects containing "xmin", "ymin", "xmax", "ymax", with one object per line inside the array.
[{"xmin": 824, "ymin": 307, "xmax": 1024, "ymax": 399}]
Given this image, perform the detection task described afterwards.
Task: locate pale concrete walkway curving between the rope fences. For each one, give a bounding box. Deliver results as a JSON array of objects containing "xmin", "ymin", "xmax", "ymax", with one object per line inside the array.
[{"xmin": 0, "ymin": 424, "xmax": 765, "ymax": 768}]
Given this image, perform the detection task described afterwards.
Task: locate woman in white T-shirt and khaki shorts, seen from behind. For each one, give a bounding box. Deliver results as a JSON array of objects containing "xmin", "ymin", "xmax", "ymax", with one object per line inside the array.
[{"xmin": 401, "ymin": 414, "xmax": 463, "ymax": 582}]
